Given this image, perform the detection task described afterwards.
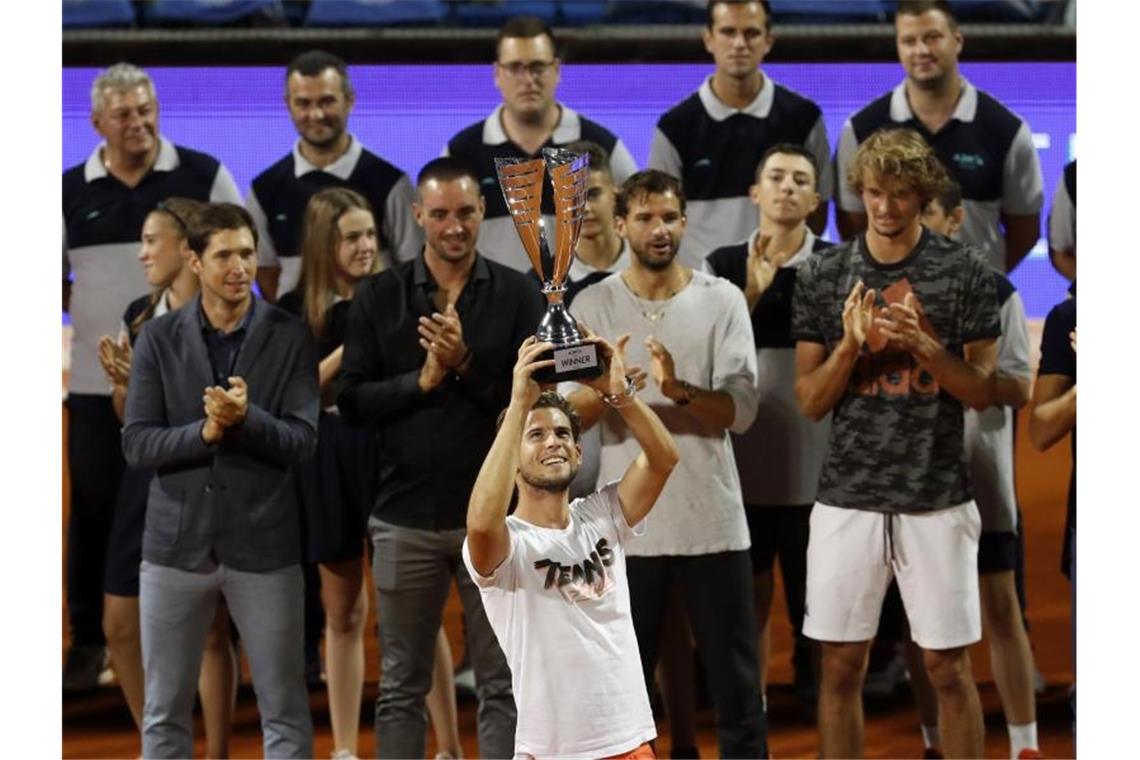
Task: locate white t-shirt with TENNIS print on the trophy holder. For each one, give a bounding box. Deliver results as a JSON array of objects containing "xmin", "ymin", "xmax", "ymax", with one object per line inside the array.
[{"xmin": 463, "ymin": 482, "xmax": 657, "ymax": 759}]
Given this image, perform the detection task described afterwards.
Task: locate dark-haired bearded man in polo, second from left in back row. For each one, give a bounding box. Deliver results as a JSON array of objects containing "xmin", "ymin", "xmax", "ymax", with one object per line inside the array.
[{"xmin": 246, "ymin": 50, "xmax": 423, "ymax": 301}]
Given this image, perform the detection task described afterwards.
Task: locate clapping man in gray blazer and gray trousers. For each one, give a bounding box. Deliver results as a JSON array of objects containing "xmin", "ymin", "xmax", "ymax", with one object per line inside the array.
[{"xmin": 123, "ymin": 204, "xmax": 319, "ymax": 758}]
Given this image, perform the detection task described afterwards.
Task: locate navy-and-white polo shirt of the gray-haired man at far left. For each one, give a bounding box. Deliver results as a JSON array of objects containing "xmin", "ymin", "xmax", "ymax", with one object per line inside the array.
[{"xmin": 63, "ymin": 137, "xmax": 242, "ymax": 395}]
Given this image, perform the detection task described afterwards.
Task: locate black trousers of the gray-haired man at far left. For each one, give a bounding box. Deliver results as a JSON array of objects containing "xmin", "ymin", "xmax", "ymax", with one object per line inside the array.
[{"xmin": 66, "ymin": 394, "xmax": 125, "ymax": 645}]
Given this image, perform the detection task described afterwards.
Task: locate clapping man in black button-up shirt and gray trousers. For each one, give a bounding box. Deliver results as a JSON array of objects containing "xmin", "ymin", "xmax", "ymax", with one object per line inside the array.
[{"xmin": 337, "ymin": 157, "xmax": 544, "ymax": 758}]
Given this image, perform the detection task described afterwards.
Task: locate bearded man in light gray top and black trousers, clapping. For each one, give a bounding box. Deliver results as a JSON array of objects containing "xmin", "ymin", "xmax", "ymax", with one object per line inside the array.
[{"xmin": 570, "ymin": 170, "xmax": 767, "ymax": 758}]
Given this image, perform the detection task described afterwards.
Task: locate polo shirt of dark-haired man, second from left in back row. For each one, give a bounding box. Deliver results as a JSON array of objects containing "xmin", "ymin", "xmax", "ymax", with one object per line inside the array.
[{"xmin": 246, "ymin": 134, "xmax": 424, "ymax": 294}]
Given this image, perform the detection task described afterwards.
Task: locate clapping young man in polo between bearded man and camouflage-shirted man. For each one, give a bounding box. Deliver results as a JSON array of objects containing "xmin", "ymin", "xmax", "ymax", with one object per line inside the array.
[{"xmin": 706, "ymin": 142, "xmax": 831, "ymax": 701}]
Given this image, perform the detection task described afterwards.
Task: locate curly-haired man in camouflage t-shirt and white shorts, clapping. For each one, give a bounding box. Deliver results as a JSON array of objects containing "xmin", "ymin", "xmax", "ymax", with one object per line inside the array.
[{"xmin": 792, "ymin": 129, "xmax": 1001, "ymax": 758}]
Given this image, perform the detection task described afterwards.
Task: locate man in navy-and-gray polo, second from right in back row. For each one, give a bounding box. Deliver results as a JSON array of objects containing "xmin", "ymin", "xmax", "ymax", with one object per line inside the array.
[{"xmin": 649, "ymin": 0, "xmax": 831, "ymax": 269}]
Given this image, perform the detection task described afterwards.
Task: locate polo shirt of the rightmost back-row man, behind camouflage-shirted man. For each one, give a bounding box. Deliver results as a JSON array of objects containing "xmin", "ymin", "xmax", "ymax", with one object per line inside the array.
[{"xmin": 836, "ymin": 79, "xmax": 1044, "ymax": 272}]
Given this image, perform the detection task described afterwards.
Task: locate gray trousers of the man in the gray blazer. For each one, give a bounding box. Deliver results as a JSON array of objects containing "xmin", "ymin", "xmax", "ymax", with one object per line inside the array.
[{"xmin": 139, "ymin": 562, "xmax": 312, "ymax": 758}]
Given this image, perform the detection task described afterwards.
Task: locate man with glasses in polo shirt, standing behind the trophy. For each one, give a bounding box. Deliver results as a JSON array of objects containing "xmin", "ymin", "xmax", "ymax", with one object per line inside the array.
[{"xmin": 443, "ymin": 16, "xmax": 637, "ymax": 271}]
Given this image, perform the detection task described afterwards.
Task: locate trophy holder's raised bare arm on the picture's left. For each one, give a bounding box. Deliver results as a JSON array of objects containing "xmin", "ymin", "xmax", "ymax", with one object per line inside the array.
[{"xmin": 467, "ymin": 335, "xmax": 554, "ymax": 577}]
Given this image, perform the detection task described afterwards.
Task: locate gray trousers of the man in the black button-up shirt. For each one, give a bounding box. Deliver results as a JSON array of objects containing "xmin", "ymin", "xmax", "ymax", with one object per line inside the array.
[{"xmin": 368, "ymin": 517, "xmax": 516, "ymax": 758}]
